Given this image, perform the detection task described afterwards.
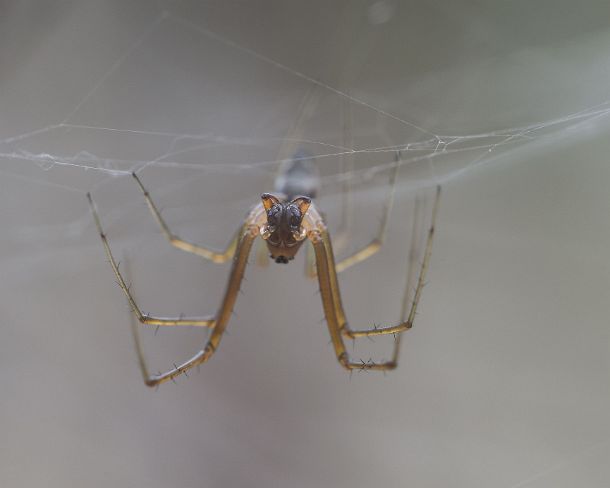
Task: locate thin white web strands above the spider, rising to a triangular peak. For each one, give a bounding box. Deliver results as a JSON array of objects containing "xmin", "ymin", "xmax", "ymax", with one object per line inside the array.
[{"xmin": 0, "ymin": 12, "xmax": 610, "ymax": 200}]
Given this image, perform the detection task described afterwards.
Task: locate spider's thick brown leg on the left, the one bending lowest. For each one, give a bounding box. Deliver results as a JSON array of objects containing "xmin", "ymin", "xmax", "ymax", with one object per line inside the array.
[{"xmin": 132, "ymin": 223, "xmax": 259, "ymax": 387}]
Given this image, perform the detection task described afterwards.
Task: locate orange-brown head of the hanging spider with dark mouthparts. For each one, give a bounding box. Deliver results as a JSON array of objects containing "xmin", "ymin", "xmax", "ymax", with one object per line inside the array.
[{"xmin": 261, "ymin": 193, "xmax": 311, "ymax": 263}]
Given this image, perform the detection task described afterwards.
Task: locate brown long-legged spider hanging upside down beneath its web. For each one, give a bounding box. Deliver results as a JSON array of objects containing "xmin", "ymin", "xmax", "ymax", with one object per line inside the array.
[{"xmin": 87, "ymin": 153, "xmax": 440, "ymax": 386}]
